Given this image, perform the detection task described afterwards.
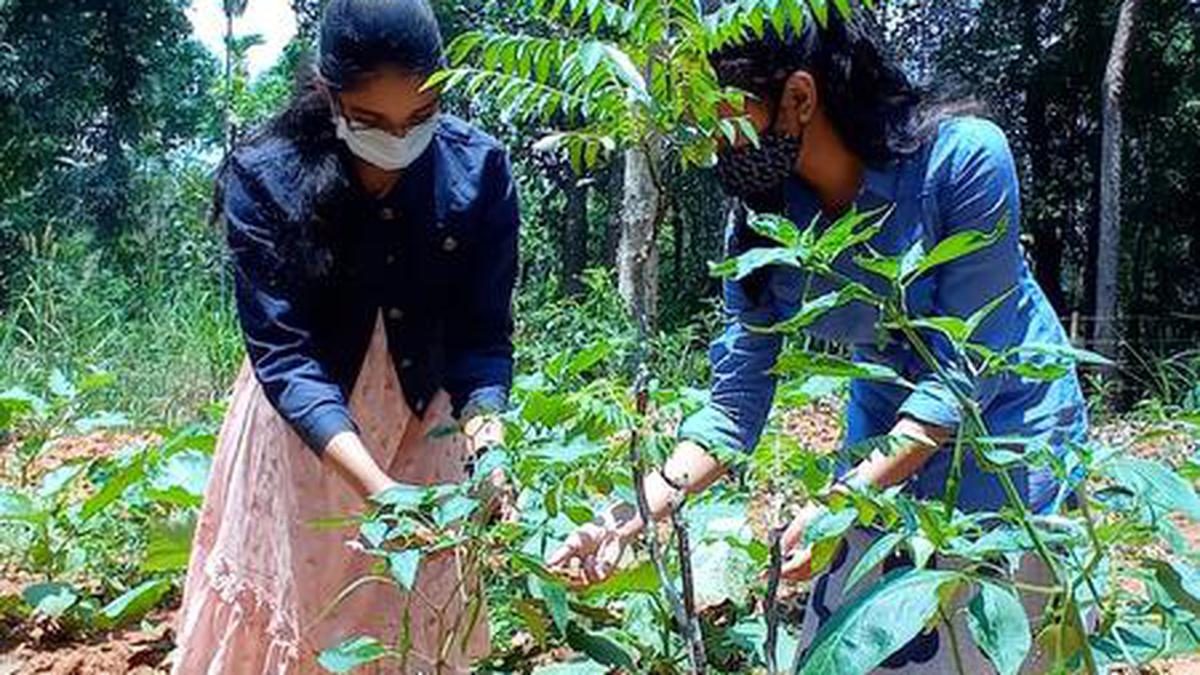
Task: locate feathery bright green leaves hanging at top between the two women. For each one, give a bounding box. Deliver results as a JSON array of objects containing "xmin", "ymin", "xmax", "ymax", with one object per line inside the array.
[{"xmin": 428, "ymin": 0, "xmax": 864, "ymax": 168}]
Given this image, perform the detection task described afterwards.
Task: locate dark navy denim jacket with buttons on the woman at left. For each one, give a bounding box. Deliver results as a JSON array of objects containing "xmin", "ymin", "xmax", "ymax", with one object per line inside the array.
[{"xmin": 223, "ymin": 115, "xmax": 518, "ymax": 453}]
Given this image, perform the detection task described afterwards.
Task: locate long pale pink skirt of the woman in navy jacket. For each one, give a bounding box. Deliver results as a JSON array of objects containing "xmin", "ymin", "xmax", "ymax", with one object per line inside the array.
[{"xmin": 174, "ymin": 323, "xmax": 488, "ymax": 675}]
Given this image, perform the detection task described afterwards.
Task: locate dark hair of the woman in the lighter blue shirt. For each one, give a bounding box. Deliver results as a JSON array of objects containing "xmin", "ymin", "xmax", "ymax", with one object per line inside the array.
[{"xmin": 710, "ymin": 2, "xmax": 973, "ymax": 165}]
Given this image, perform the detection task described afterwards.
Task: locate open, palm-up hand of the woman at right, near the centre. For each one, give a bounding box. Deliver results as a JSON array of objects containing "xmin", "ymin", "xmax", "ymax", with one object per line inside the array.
[{"xmin": 546, "ymin": 503, "xmax": 641, "ymax": 586}]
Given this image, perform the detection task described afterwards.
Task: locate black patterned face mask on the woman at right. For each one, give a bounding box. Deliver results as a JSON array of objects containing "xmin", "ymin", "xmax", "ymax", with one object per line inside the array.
[{"xmin": 716, "ymin": 131, "xmax": 800, "ymax": 214}]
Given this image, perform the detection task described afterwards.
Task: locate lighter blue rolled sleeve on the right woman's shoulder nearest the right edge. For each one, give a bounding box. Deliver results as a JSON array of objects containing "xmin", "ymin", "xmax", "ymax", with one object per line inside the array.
[{"xmin": 900, "ymin": 119, "xmax": 1022, "ymax": 428}]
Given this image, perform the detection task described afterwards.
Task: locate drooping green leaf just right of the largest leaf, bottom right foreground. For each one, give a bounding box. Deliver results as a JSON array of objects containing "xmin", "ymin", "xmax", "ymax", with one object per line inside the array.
[{"xmin": 967, "ymin": 581, "xmax": 1033, "ymax": 675}]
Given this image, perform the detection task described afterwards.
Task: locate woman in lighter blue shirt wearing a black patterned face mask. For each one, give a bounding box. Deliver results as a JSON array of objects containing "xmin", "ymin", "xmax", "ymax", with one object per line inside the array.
[{"xmin": 550, "ymin": 6, "xmax": 1086, "ymax": 671}]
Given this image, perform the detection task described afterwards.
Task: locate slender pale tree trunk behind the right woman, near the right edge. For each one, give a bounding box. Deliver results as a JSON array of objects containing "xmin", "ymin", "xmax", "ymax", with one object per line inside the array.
[{"xmin": 1094, "ymin": 0, "xmax": 1138, "ymax": 357}]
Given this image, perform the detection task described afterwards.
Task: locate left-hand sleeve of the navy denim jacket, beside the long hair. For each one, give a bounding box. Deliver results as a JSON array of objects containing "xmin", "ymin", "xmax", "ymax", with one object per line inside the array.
[{"xmin": 224, "ymin": 160, "xmax": 358, "ymax": 454}]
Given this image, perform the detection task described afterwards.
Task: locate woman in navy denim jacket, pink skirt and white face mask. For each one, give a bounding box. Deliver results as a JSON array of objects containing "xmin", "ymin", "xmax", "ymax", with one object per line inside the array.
[{"xmin": 175, "ymin": 0, "xmax": 518, "ymax": 675}]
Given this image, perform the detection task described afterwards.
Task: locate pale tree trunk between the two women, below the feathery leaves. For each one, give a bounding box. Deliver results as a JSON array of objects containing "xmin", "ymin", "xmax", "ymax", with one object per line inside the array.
[{"xmin": 617, "ymin": 148, "xmax": 662, "ymax": 328}]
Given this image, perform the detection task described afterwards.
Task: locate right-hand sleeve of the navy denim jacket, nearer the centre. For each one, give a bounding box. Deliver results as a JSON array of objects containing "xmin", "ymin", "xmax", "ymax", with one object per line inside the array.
[{"xmin": 446, "ymin": 150, "xmax": 521, "ymax": 417}]
